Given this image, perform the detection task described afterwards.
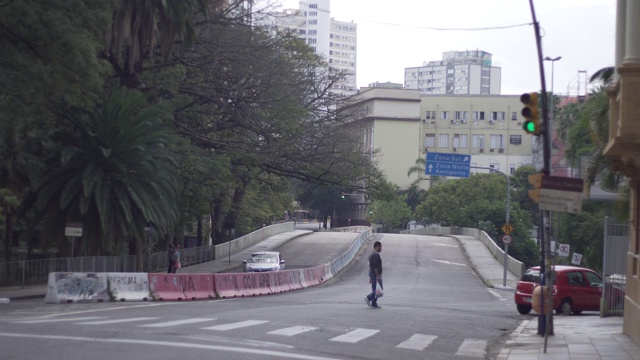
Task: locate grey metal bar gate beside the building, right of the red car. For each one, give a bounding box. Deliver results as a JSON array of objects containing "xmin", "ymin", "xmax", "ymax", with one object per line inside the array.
[{"xmin": 600, "ymin": 217, "xmax": 629, "ymax": 316}]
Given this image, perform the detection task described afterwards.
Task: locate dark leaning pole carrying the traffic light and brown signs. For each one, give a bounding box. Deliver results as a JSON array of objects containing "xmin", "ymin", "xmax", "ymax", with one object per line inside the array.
[{"xmin": 529, "ymin": 0, "xmax": 553, "ymax": 344}]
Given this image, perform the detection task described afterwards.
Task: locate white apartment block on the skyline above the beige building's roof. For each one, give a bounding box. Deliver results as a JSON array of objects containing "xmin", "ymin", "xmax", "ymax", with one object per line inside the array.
[{"xmin": 404, "ymin": 50, "xmax": 501, "ymax": 95}]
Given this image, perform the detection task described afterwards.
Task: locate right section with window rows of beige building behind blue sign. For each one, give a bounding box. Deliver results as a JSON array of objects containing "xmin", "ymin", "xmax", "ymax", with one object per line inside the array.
[{"xmin": 420, "ymin": 95, "xmax": 533, "ymax": 175}]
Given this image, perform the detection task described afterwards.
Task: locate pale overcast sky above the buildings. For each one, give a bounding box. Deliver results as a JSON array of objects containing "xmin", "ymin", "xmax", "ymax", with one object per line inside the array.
[{"xmin": 280, "ymin": 0, "xmax": 616, "ymax": 95}]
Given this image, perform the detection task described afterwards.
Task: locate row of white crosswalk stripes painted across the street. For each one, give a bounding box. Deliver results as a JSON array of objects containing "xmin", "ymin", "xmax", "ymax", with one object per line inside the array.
[{"xmin": 2, "ymin": 316, "xmax": 487, "ymax": 358}]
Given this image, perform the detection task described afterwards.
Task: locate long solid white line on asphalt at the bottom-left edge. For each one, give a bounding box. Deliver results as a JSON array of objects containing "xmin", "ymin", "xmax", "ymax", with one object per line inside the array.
[{"xmin": 0, "ymin": 332, "xmax": 342, "ymax": 360}]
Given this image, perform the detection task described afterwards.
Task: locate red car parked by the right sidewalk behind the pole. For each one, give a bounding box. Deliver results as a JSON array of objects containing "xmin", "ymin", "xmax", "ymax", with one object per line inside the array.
[{"xmin": 514, "ymin": 265, "xmax": 624, "ymax": 315}]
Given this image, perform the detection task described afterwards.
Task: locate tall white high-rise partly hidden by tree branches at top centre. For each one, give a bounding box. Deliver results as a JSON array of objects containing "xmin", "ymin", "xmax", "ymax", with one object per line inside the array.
[{"xmin": 267, "ymin": 0, "xmax": 358, "ymax": 95}]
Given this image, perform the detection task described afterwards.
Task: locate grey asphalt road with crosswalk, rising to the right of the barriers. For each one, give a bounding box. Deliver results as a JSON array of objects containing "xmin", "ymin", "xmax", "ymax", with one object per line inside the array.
[{"xmin": 0, "ymin": 234, "xmax": 521, "ymax": 360}]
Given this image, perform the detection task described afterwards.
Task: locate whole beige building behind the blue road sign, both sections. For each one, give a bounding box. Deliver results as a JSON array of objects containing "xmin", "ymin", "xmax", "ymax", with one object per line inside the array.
[{"xmin": 344, "ymin": 86, "xmax": 533, "ymax": 189}]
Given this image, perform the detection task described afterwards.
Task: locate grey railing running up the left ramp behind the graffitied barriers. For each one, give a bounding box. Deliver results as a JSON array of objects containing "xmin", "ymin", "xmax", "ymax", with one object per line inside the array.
[{"xmin": 0, "ymin": 222, "xmax": 294, "ymax": 287}]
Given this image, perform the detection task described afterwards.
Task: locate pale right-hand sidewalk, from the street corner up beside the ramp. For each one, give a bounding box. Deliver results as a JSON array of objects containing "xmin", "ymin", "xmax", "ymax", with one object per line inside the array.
[{"xmin": 454, "ymin": 236, "xmax": 640, "ymax": 360}]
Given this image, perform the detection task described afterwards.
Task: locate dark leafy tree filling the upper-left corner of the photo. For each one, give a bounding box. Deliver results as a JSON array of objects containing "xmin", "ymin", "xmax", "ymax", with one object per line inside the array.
[{"xmin": 0, "ymin": 0, "xmax": 114, "ymax": 262}]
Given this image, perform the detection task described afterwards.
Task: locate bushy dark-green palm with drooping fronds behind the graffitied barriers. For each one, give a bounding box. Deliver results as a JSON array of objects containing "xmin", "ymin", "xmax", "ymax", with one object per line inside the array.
[{"xmin": 38, "ymin": 90, "xmax": 181, "ymax": 262}]
